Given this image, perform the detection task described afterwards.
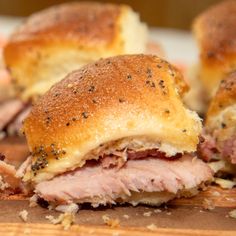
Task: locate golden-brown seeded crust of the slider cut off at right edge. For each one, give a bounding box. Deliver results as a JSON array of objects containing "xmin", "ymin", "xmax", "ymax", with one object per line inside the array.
[{"xmin": 206, "ymin": 72, "xmax": 236, "ymax": 124}]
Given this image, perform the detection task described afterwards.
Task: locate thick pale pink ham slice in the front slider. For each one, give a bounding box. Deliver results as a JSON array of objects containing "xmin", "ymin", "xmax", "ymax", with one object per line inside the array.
[{"xmin": 35, "ymin": 155, "xmax": 212, "ymax": 204}]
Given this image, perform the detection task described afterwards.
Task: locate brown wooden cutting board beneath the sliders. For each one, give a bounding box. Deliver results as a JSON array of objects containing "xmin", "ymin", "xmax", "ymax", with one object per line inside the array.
[{"xmin": 0, "ymin": 138, "xmax": 236, "ymax": 236}]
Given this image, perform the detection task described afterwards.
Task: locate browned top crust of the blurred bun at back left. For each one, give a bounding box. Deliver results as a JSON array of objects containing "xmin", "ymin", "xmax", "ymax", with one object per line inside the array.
[{"xmin": 7, "ymin": 2, "xmax": 121, "ymax": 49}]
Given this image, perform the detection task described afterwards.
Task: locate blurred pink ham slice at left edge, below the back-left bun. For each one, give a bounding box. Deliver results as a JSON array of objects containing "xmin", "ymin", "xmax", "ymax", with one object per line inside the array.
[{"xmin": 0, "ymin": 99, "xmax": 24, "ymax": 131}]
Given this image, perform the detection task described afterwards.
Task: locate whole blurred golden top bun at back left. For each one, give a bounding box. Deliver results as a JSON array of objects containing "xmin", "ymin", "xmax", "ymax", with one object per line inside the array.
[{"xmin": 4, "ymin": 2, "xmax": 147, "ymax": 100}]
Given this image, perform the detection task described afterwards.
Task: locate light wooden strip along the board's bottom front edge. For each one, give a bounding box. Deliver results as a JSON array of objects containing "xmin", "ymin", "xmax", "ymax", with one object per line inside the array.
[{"xmin": 0, "ymin": 224, "xmax": 235, "ymax": 236}]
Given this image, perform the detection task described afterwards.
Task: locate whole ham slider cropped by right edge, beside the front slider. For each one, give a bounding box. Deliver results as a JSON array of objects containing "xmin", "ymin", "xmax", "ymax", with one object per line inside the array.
[{"xmin": 199, "ymin": 72, "xmax": 236, "ymax": 174}]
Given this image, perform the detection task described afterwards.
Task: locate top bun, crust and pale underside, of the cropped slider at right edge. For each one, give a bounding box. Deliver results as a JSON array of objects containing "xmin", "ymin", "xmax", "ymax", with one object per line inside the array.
[{"xmin": 206, "ymin": 72, "xmax": 236, "ymax": 131}]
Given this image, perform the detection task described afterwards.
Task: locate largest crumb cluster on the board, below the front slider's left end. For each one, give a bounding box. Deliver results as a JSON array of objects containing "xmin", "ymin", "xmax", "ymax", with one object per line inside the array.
[{"xmin": 45, "ymin": 212, "xmax": 75, "ymax": 230}]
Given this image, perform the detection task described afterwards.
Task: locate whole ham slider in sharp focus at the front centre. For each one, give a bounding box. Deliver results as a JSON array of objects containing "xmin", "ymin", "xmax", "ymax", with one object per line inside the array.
[{"xmin": 18, "ymin": 55, "xmax": 212, "ymax": 207}]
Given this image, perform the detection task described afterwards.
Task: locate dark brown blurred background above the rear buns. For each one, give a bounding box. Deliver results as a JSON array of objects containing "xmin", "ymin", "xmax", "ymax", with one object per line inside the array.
[{"xmin": 0, "ymin": 0, "xmax": 223, "ymax": 29}]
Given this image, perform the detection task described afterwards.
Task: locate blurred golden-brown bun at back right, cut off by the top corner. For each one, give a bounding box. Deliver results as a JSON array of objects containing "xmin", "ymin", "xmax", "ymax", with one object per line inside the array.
[{"xmin": 193, "ymin": 1, "xmax": 236, "ymax": 98}]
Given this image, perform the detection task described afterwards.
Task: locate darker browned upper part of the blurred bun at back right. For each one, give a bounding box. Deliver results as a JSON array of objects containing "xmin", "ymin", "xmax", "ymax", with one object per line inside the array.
[{"xmin": 193, "ymin": 0, "xmax": 236, "ymax": 64}]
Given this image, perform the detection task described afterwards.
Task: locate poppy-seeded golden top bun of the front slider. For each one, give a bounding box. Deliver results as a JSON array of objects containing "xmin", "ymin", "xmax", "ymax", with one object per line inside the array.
[{"xmin": 24, "ymin": 55, "xmax": 201, "ymax": 182}]
